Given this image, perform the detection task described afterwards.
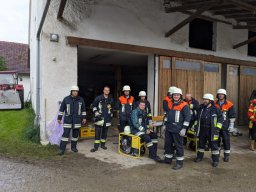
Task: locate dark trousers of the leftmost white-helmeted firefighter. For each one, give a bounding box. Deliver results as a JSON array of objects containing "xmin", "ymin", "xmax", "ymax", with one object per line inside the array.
[{"xmin": 60, "ymin": 128, "xmax": 79, "ymax": 151}]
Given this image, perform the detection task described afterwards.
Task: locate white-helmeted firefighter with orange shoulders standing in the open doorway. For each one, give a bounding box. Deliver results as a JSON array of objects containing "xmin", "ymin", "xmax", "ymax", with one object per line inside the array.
[{"xmin": 117, "ymin": 85, "xmax": 135, "ymax": 133}]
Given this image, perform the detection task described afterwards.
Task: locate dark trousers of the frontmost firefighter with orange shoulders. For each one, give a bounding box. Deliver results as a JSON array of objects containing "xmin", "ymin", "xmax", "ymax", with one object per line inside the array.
[{"xmin": 165, "ymin": 130, "xmax": 184, "ymax": 161}]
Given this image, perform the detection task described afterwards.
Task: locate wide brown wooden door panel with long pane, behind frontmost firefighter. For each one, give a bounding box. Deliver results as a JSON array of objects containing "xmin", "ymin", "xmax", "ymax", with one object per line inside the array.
[{"xmin": 172, "ymin": 57, "xmax": 203, "ymax": 100}]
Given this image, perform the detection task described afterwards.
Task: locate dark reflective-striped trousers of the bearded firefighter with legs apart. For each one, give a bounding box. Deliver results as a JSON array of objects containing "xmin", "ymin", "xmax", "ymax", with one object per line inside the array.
[{"xmin": 197, "ymin": 131, "xmax": 220, "ymax": 162}]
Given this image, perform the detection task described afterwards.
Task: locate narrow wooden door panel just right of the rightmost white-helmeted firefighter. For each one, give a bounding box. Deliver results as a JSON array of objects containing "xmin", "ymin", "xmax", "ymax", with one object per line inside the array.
[{"xmin": 226, "ymin": 65, "xmax": 239, "ymax": 124}]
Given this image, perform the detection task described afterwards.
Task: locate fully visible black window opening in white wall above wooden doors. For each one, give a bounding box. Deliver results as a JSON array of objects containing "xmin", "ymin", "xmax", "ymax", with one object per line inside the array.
[{"xmin": 189, "ymin": 19, "xmax": 214, "ymax": 51}]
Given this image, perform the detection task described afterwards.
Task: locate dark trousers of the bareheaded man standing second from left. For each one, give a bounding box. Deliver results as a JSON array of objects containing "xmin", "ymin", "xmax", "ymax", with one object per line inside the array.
[{"xmin": 94, "ymin": 124, "xmax": 108, "ymax": 149}]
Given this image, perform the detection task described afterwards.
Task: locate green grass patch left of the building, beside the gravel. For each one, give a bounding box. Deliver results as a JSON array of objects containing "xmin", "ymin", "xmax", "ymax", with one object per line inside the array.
[{"xmin": 0, "ymin": 109, "xmax": 61, "ymax": 159}]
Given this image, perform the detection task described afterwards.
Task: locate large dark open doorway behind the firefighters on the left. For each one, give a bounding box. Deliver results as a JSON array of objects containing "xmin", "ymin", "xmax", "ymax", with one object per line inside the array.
[{"xmin": 78, "ymin": 47, "xmax": 148, "ymax": 121}]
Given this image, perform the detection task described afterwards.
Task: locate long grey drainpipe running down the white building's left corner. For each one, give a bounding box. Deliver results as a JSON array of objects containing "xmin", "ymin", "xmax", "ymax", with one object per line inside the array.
[{"xmin": 34, "ymin": 0, "xmax": 51, "ymax": 132}]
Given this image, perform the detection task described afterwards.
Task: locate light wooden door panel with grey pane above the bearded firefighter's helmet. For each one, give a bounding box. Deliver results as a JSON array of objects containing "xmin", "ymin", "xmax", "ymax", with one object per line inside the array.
[{"xmin": 204, "ymin": 62, "xmax": 221, "ymax": 97}]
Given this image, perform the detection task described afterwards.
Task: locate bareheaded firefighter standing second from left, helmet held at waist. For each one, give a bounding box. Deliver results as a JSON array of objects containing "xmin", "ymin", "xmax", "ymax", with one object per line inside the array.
[{"xmin": 91, "ymin": 86, "xmax": 114, "ymax": 152}]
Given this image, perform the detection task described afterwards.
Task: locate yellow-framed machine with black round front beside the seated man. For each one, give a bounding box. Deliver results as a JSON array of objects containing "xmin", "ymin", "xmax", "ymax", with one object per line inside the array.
[{"xmin": 118, "ymin": 133, "xmax": 146, "ymax": 158}]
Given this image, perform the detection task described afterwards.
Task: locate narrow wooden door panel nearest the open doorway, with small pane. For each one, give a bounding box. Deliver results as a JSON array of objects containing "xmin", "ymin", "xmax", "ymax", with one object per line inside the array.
[{"xmin": 158, "ymin": 56, "xmax": 172, "ymax": 115}]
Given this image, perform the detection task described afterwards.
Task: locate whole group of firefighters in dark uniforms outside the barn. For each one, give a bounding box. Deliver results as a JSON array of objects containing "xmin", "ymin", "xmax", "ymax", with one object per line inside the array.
[{"xmin": 58, "ymin": 85, "xmax": 256, "ymax": 170}]
